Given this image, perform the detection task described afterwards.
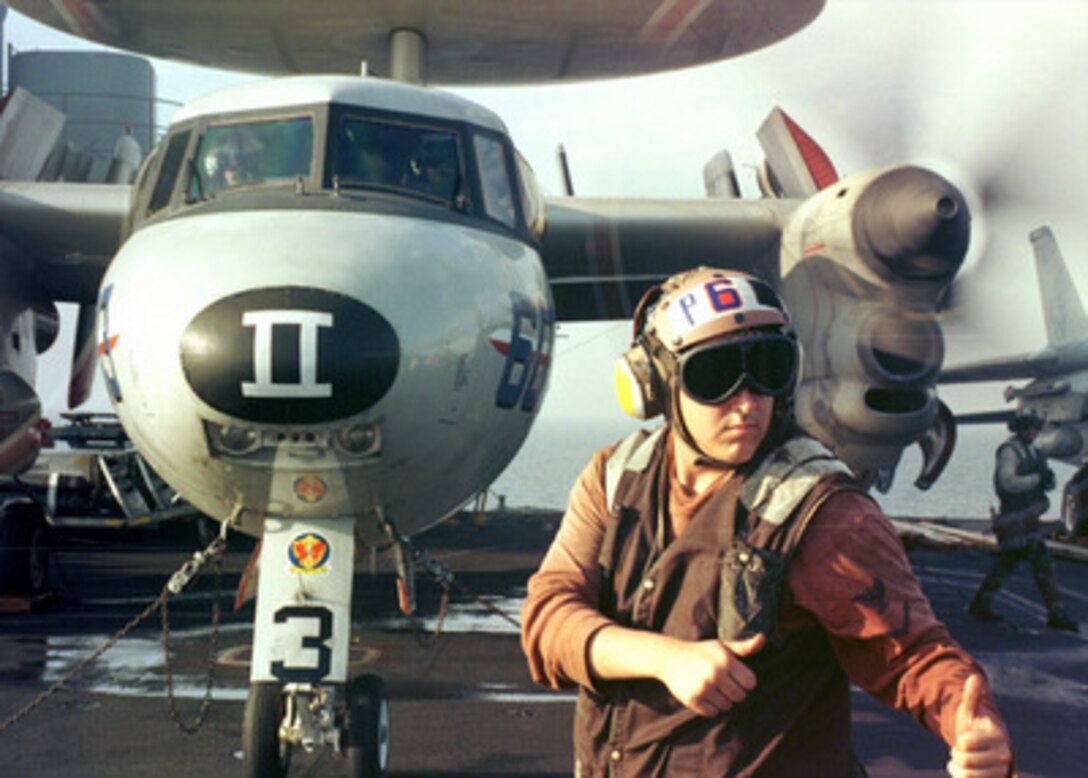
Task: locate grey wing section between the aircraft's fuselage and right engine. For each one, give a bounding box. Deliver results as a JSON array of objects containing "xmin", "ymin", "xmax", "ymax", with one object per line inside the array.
[{"xmin": 542, "ymin": 197, "xmax": 796, "ymax": 320}]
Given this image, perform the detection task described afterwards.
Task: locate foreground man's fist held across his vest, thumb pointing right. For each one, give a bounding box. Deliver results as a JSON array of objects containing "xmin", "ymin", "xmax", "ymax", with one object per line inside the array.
[{"xmin": 660, "ymin": 633, "xmax": 767, "ymax": 716}]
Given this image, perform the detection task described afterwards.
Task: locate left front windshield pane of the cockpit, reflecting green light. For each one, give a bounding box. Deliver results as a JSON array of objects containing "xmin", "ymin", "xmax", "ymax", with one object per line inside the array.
[{"xmin": 188, "ymin": 116, "xmax": 313, "ymax": 202}]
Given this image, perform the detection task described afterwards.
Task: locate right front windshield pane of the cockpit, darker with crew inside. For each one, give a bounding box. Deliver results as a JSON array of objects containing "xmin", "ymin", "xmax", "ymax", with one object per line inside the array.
[{"xmin": 332, "ymin": 116, "xmax": 463, "ymax": 206}]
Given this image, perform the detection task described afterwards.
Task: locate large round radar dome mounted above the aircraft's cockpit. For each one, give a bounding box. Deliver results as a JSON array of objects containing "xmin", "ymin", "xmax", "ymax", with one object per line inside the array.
[{"xmin": 5, "ymin": 0, "xmax": 825, "ymax": 84}]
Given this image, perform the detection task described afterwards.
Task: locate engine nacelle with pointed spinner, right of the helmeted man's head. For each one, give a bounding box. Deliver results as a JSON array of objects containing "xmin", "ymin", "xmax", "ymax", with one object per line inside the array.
[{"xmin": 781, "ymin": 166, "xmax": 970, "ymax": 482}]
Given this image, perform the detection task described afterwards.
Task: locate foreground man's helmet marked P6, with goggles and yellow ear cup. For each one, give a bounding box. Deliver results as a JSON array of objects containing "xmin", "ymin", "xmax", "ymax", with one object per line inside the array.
[{"xmin": 615, "ymin": 267, "xmax": 800, "ymax": 427}]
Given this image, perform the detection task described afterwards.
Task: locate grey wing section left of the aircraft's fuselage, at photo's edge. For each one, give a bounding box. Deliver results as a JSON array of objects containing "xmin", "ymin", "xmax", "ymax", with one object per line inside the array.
[{"xmin": 0, "ymin": 181, "xmax": 131, "ymax": 304}]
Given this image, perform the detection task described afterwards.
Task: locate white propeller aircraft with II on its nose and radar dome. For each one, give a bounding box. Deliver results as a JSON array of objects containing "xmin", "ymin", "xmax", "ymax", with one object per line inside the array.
[{"xmin": 0, "ymin": 0, "xmax": 969, "ymax": 776}]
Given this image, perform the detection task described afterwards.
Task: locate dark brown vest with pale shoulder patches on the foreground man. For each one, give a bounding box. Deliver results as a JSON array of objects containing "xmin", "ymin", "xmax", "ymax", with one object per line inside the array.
[{"xmin": 574, "ymin": 431, "xmax": 864, "ymax": 778}]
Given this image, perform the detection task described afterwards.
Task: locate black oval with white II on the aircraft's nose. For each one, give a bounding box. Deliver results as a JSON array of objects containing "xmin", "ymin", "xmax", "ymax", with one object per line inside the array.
[{"xmin": 181, "ymin": 286, "xmax": 400, "ymax": 423}]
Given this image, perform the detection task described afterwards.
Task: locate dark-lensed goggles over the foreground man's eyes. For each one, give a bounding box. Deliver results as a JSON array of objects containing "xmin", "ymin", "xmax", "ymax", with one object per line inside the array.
[{"xmin": 677, "ymin": 334, "xmax": 798, "ymax": 405}]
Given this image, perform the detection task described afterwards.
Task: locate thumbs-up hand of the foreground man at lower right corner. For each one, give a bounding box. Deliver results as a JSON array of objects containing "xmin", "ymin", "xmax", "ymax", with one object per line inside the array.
[{"xmin": 948, "ymin": 675, "xmax": 1014, "ymax": 778}]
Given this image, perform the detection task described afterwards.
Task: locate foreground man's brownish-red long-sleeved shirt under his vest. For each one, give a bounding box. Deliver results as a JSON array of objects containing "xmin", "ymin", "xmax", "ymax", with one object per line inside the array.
[{"xmin": 521, "ymin": 437, "xmax": 997, "ymax": 744}]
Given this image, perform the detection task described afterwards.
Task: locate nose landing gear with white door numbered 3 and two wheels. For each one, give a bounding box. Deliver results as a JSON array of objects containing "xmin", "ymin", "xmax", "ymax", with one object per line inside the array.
[{"xmin": 243, "ymin": 518, "xmax": 390, "ymax": 778}]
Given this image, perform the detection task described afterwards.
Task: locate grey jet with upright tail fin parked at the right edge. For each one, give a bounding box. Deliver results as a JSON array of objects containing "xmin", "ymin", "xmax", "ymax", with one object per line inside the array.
[{"xmin": 938, "ymin": 226, "xmax": 1088, "ymax": 466}]
